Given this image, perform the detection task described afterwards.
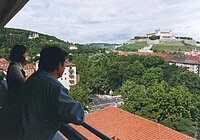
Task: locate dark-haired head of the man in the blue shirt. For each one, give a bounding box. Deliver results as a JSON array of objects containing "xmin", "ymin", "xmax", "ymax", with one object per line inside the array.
[{"xmin": 39, "ymin": 46, "xmax": 68, "ymax": 78}]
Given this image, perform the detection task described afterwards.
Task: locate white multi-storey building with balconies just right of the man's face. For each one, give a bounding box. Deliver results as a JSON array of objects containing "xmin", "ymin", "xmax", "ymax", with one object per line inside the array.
[{"xmin": 58, "ymin": 61, "xmax": 79, "ymax": 90}]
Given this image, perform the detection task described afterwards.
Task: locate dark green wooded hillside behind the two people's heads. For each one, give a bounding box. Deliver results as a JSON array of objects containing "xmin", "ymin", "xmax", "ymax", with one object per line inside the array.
[{"xmin": 0, "ymin": 28, "xmax": 103, "ymax": 60}]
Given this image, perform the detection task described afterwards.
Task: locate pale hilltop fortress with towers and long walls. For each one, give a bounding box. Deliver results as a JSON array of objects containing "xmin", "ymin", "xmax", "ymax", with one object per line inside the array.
[{"xmin": 126, "ymin": 29, "xmax": 197, "ymax": 45}]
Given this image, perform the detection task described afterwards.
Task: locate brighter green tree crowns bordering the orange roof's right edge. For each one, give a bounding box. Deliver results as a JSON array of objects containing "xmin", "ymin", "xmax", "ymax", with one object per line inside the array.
[{"xmin": 120, "ymin": 80, "xmax": 200, "ymax": 137}]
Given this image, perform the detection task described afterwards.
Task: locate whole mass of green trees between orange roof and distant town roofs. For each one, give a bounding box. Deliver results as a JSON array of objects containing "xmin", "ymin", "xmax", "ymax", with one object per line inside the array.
[{"xmin": 69, "ymin": 47, "xmax": 200, "ymax": 136}]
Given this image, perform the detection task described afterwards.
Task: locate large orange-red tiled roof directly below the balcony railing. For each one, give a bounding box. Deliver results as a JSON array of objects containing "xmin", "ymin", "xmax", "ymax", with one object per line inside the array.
[{"xmin": 70, "ymin": 106, "xmax": 194, "ymax": 140}]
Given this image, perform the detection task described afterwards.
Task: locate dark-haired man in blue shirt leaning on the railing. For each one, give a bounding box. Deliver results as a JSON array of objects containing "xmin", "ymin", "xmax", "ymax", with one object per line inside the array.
[{"xmin": 0, "ymin": 47, "xmax": 84, "ymax": 140}]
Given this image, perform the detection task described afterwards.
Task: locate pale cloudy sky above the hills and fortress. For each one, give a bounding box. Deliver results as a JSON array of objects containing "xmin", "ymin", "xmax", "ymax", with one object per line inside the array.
[{"xmin": 6, "ymin": 0, "xmax": 200, "ymax": 43}]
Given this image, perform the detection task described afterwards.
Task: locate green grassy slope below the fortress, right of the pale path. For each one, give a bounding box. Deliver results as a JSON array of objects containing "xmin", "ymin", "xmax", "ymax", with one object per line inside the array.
[{"xmin": 152, "ymin": 42, "xmax": 199, "ymax": 52}]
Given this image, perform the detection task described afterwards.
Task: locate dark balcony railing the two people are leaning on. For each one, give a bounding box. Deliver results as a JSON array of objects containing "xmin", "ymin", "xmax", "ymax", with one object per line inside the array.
[{"xmin": 0, "ymin": 80, "xmax": 112, "ymax": 140}]
